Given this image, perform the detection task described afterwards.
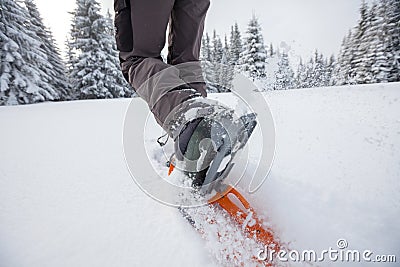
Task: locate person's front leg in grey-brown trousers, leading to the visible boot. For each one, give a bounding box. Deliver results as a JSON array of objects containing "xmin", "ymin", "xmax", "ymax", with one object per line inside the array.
[{"xmin": 114, "ymin": 0, "xmax": 203, "ymax": 125}]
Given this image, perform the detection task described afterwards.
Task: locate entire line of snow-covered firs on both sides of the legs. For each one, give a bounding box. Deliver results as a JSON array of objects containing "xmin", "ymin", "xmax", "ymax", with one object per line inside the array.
[{"xmin": 0, "ymin": 0, "xmax": 400, "ymax": 105}]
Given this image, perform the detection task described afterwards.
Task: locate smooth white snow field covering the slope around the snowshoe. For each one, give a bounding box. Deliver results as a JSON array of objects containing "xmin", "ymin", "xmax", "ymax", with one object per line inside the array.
[{"xmin": 0, "ymin": 83, "xmax": 400, "ymax": 266}]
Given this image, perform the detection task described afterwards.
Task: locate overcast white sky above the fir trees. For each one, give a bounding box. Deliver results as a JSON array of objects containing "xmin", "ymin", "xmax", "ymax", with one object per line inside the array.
[{"xmin": 32, "ymin": 0, "xmax": 370, "ymax": 57}]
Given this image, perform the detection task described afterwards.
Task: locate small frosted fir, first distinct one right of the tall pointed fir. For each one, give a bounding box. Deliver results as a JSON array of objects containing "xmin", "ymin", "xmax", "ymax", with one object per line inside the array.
[{"xmin": 274, "ymin": 52, "xmax": 294, "ymax": 90}]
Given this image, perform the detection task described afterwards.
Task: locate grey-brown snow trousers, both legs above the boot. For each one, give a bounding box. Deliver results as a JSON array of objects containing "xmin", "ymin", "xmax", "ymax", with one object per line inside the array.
[{"xmin": 114, "ymin": 0, "xmax": 210, "ymax": 129}]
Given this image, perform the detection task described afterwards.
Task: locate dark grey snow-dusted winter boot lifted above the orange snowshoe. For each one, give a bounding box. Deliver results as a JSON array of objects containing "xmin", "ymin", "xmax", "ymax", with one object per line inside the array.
[{"xmin": 175, "ymin": 113, "xmax": 257, "ymax": 191}]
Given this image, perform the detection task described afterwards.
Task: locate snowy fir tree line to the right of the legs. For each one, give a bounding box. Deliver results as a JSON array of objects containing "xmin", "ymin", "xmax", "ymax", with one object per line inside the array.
[{"xmin": 202, "ymin": 0, "xmax": 400, "ymax": 92}]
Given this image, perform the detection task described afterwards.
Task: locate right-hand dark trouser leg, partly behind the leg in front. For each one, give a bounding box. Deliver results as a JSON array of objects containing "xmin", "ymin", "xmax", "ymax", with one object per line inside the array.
[{"xmin": 168, "ymin": 0, "xmax": 210, "ymax": 96}]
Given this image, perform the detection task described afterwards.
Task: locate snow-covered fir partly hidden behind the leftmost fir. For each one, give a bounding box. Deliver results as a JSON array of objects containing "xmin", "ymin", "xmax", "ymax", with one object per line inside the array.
[{"xmin": 25, "ymin": 0, "xmax": 70, "ymax": 100}]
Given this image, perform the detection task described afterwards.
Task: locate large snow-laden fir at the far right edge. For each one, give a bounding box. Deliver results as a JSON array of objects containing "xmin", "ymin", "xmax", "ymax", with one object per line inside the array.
[{"xmin": 333, "ymin": 0, "xmax": 400, "ymax": 85}]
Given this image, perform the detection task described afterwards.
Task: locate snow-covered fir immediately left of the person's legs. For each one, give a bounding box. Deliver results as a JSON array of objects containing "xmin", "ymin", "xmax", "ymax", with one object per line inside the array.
[{"xmin": 69, "ymin": 0, "xmax": 131, "ymax": 99}]
